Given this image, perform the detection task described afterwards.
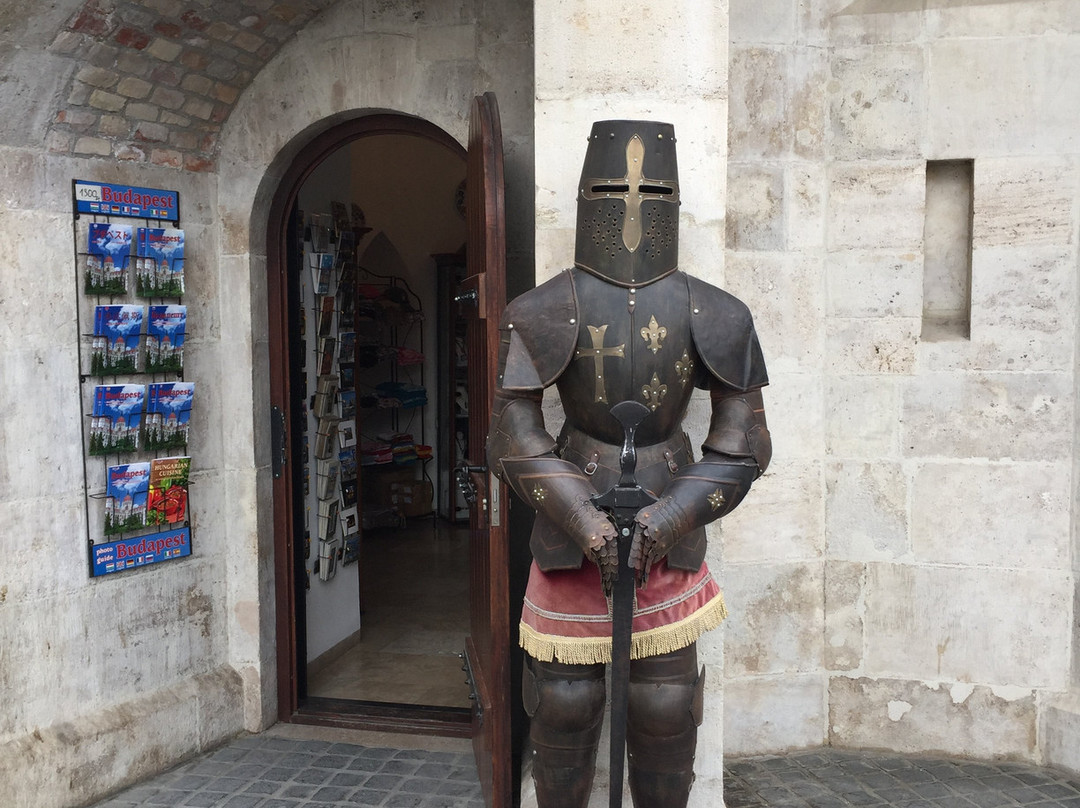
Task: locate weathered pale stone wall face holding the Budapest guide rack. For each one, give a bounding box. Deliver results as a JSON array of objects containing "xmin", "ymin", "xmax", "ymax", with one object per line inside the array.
[{"xmin": 0, "ymin": 146, "xmax": 243, "ymax": 808}]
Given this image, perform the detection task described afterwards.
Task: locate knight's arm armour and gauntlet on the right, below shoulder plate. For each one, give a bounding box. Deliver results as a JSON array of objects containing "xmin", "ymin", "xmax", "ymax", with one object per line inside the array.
[{"xmin": 630, "ymin": 390, "xmax": 772, "ymax": 587}]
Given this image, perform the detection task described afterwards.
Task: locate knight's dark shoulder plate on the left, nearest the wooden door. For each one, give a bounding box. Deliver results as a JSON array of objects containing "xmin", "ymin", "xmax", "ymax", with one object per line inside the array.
[{"xmin": 500, "ymin": 271, "xmax": 578, "ymax": 390}]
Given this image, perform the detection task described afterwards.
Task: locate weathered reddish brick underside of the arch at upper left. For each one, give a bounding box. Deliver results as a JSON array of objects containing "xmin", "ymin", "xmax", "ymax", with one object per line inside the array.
[{"xmin": 46, "ymin": 0, "xmax": 337, "ymax": 172}]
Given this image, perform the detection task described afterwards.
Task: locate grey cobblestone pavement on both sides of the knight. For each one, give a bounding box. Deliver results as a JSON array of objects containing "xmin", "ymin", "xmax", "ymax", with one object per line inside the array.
[{"xmin": 95, "ymin": 733, "xmax": 1080, "ymax": 808}]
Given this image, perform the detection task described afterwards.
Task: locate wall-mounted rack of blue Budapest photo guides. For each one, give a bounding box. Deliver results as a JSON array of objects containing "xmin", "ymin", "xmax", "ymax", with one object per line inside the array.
[{"xmin": 71, "ymin": 179, "xmax": 194, "ymax": 578}]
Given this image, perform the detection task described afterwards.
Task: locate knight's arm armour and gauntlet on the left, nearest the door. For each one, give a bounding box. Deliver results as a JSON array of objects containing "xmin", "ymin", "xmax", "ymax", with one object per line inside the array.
[{"xmin": 487, "ymin": 390, "xmax": 618, "ymax": 579}]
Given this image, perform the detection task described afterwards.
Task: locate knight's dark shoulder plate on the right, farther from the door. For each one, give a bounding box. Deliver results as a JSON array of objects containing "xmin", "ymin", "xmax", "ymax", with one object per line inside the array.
[{"xmin": 686, "ymin": 275, "xmax": 769, "ymax": 392}]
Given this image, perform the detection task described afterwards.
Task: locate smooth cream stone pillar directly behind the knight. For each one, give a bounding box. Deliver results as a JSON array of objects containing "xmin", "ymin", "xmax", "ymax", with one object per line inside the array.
[{"xmin": 533, "ymin": 0, "xmax": 728, "ymax": 807}]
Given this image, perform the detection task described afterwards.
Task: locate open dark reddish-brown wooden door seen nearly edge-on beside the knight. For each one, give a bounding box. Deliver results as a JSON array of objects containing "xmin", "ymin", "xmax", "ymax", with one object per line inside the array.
[{"xmin": 458, "ymin": 93, "xmax": 512, "ymax": 808}]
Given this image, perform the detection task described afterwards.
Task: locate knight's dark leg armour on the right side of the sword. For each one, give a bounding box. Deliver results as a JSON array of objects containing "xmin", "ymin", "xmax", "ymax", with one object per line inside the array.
[{"xmin": 626, "ymin": 645, "xmax": 705, "ymax": 808}]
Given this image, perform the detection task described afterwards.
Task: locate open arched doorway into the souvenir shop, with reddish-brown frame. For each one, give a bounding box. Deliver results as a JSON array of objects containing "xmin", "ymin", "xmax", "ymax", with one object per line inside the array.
[{"xmin": 268, "ymin": 113, "xmax": 471, "ymax": 736}]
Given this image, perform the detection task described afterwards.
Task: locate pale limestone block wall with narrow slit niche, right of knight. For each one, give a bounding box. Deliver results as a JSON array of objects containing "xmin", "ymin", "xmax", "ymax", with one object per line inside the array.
[{"xmin": 725, "ymin": 2, "xmax": 1080, "ymax": 768}]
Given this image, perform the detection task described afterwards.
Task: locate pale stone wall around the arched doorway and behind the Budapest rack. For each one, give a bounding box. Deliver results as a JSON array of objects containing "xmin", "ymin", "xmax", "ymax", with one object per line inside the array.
[{"xmin": 0, "ymin": 0, "xmax": 532, "ymax": 808}]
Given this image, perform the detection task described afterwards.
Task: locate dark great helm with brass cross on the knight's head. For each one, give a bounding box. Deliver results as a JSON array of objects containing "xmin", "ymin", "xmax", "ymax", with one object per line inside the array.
[{"xmin": 573, "ymin": 121, "xmax": 679, "ymax": 286}]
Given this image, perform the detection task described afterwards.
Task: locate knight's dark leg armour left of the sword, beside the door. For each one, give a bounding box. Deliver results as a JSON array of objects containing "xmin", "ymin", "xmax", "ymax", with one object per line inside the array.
[{"xmin": 522, "ymin": 656, "xmax": 607, "ymax": 808}]
